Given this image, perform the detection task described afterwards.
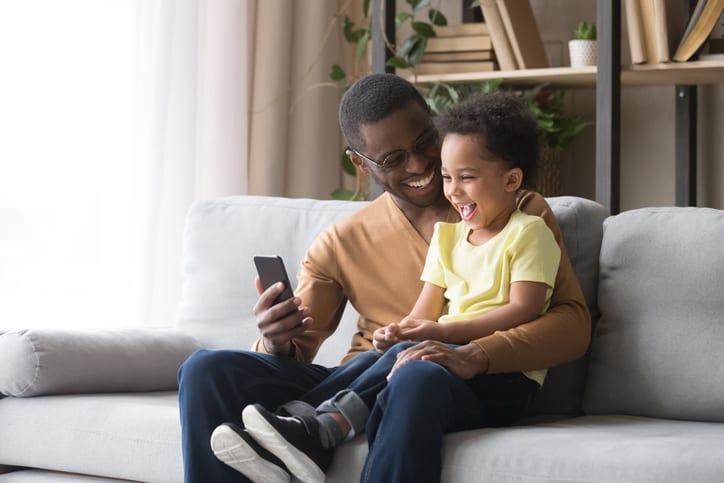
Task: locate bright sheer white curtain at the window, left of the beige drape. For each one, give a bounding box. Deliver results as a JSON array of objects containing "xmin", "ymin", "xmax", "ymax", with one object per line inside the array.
[{"xmin": 0, "ymin": 0, "xmax": 248, "ymax": 329}]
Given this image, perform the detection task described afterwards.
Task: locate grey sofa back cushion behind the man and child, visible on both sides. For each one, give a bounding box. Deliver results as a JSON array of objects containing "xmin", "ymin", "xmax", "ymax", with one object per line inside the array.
[{"xmin": 176, "ymin": 196, "xmax": 607, "ymax": 384}]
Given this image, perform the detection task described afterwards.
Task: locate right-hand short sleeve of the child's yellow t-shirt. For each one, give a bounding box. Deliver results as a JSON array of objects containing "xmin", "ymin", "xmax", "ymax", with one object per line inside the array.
[{"xmin": 510, "ymin": 219, "xmax": 561, "ymax": 288}]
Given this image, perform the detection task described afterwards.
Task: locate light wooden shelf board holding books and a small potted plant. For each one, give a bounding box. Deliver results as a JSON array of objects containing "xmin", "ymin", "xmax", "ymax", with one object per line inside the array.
[{"xmin": 405, "ymin": 60, "xmax": 724, "ymax": 88}]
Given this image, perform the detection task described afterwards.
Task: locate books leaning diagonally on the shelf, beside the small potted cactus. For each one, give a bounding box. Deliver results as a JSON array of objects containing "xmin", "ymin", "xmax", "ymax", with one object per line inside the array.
[{"xmin": 480, "ymin": 0, "xmax": 549, "ymax": 70}]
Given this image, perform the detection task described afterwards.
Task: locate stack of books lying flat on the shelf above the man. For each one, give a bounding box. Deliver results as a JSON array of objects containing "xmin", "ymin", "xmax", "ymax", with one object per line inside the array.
[{"xmin": 415, "ymin": 22, "xmax": 498, "ymax": 75}]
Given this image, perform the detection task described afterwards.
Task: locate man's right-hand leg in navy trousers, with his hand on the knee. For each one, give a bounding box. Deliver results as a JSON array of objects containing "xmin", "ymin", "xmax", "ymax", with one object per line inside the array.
[{"xmin": 361, "ymin": 361, "xmax": 538, "ymax": 483}]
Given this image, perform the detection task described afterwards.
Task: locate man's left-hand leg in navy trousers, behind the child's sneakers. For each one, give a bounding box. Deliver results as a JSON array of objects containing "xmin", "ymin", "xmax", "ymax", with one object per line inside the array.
[{"xmin": 179, "ymin": 350, "xmax": 333, "ymax": 483}]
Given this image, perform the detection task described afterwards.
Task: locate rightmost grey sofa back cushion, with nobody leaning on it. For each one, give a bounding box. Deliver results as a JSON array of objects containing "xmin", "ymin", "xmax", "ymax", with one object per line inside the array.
[{"xmin": 584, "ymin": 208, "xmax": 724, "ymax": 422}]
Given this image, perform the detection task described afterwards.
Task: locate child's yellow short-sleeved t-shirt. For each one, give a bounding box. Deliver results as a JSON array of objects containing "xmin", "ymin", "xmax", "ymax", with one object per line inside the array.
[{"xmin": 420, "ymin": 211, "xmax": 561, "ymax": 384}]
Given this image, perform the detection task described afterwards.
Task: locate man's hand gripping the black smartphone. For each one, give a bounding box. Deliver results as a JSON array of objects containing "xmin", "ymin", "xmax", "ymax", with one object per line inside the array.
[{"xmin": 254, "ymin": 277, "xmax": 313, "ymax": 356}]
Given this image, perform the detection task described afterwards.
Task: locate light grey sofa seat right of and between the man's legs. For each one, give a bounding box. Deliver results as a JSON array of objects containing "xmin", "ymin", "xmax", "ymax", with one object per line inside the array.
[{"xmin": 326, "ymin": 416, "xmax": 724, "ymax": 483}]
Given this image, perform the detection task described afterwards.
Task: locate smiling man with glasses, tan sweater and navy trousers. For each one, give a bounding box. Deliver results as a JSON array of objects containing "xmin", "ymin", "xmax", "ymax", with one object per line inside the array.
[{"xmin": 179, "ymin": 74, "xmax": 590, "ymax": 482}]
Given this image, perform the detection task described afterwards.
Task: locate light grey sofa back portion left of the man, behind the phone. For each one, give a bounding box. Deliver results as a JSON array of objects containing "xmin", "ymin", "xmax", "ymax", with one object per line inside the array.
[{"xmin": 176, "ymin": 196, "xmax": 367, "ymax": 365}]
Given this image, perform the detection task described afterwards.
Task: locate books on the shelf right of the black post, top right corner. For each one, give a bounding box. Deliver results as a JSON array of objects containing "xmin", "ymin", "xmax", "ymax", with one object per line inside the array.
[{"xmin": 624, "ymin": 0, "xmax": 724, "ymax": 64}]
